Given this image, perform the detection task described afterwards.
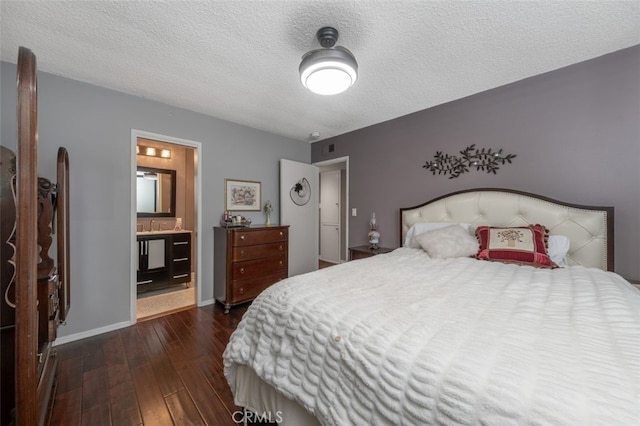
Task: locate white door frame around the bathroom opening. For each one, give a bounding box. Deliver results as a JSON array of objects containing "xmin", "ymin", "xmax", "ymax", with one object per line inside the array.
[{"xmin": 129, "ymin": 129, "xmax": 202, "ymax": 324}]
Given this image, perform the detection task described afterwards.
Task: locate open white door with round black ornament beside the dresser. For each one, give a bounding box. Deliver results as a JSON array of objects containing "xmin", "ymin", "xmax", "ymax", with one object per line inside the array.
[{"xmin": 280, "ymin": 159, "xmax": 318, "ymax": 276}]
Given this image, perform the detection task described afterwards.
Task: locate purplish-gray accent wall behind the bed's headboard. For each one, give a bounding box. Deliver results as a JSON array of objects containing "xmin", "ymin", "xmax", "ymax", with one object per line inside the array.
[{"xmin": 311, "ymin": 46, "xmax": 640, "ymax": 279}]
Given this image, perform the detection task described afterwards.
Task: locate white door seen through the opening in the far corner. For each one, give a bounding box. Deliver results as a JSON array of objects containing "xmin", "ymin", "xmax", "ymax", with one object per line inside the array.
[{"xmin": 320, "ymin": 170, "xmax": 341, "ymax": 263}]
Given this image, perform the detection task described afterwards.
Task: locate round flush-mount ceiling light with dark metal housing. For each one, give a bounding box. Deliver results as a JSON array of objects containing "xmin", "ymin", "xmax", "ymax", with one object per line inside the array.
[{"xmin": 300, "ymin": 27, "xmax": 358, "ymax": 95}]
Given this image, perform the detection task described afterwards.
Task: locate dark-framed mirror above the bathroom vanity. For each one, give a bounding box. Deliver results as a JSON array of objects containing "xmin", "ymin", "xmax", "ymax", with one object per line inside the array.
[{"xmin": 136, "ymin": 166, "xmax": 176, "ymax": 217}]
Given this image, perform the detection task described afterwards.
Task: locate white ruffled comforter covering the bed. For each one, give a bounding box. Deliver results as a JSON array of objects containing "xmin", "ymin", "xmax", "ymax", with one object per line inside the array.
[{"xmin": 224, "ymin": 248, "xmax": 640, "ymax": 425}]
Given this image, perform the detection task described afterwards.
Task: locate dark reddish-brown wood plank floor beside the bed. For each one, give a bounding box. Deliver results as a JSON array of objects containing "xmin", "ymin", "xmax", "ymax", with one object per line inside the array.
[{"xmin": 50, "ymin": 304, "xmax": 268, "ymax": 426}]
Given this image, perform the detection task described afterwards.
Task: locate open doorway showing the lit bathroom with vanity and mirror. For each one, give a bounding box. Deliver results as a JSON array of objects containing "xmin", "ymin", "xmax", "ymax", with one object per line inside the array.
[{"xmin": 131, "ymin": 130, "xmax": 201, "ymax": 323}]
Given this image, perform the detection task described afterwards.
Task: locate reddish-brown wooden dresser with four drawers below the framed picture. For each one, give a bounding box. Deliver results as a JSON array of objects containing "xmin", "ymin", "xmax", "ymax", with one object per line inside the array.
[{"xmin": 213, "ymin": 225, "xmax": 289, "ymax": 313}]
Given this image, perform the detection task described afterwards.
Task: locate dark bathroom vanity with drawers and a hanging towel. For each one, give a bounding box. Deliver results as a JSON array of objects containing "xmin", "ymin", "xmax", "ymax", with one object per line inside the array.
[{"xmin": 137, "ymin": 231, "xmax": 191, "ymax": 293}]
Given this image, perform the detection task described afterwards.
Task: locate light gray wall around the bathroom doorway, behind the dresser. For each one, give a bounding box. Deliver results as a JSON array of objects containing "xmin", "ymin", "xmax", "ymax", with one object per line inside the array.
[{"xmin": 0, "ymin": 62, "xmax": 310, "ymax": 336}]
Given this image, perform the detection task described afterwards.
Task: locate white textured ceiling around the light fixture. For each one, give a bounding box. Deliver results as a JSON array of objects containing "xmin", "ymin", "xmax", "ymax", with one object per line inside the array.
[{"xmin": 0, "ymin": 0, "xmax": 640, "ymax": 141}]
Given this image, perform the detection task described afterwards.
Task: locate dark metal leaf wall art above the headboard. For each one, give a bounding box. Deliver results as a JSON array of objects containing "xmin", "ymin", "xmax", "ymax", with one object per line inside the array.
[{"xmin": 422, "ymin": 144, "xmax": 516, "ymax": 179}]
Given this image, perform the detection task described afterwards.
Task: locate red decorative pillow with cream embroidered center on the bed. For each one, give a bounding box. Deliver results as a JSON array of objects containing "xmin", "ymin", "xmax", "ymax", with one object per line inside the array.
[{"xmin": 476, "ymin": 225, "xmax": 558, "ymax": 268}]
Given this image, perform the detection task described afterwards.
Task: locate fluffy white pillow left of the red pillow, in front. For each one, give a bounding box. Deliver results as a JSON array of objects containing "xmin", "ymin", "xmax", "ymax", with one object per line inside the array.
[{"xmin": 414, "ymin": 224, "xmax": 479, "ymax": 259}]
